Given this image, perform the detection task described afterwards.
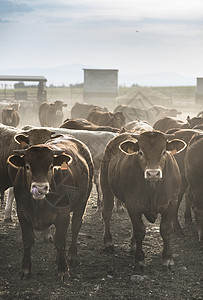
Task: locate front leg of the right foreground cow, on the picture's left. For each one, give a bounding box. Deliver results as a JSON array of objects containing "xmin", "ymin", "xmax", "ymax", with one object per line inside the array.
[{"xmin": 126, "ymin": 207, "xmax": 146, "ymax": 268}]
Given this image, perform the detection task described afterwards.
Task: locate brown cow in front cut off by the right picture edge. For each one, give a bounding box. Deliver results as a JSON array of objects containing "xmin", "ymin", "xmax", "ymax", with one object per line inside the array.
[{"xmin": 185, "ymin": 134, "xmax": 203, "ymax": 245}]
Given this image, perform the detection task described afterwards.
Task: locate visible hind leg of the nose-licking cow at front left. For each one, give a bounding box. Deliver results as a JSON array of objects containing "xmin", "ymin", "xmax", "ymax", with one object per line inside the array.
[{"xmin": 68, "ymin": 207, "xmax": 85, "ymax": 265}]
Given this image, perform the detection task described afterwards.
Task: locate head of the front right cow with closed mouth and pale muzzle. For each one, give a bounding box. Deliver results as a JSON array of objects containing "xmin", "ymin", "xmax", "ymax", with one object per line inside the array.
[{"xmin": 119, "ymin": 131, "xmax": 186, "ymax": 182}]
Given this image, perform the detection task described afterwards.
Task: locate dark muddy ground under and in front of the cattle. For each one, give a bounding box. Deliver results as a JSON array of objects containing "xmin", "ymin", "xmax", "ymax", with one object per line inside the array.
[{"xmin": 0, "ymin": 185, "xmax": 203, "ymax": 300}]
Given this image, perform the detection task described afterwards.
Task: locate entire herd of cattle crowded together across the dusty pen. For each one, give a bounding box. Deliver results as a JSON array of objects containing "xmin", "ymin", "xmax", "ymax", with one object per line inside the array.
[{"xmin": 0, "ymin": 101, "xmax": 203, "ymax": 280}]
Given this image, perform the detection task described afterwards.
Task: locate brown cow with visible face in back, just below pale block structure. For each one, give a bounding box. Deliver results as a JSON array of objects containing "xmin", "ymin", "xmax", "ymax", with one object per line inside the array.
[{"xmin": 87, "ymin": 108, "xmax": 125, "ymax": 128}]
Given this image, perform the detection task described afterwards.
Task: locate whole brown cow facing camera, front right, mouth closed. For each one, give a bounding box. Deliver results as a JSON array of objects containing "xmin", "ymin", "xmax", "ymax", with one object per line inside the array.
[{"xmin": 101, "ymin": 131, "xmax": 185, "ymax": 268}]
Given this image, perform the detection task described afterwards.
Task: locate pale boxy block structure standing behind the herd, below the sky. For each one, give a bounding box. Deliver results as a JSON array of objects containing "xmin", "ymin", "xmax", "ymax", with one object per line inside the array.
[{"xmin": 83, "ymin": 69, "xmax": 118, "ymax": 107}]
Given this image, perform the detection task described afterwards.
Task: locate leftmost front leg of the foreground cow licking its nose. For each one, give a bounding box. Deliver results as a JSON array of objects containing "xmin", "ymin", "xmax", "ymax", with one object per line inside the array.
[{"xmin": 17, "ymin": 210, "xmax": 34, "ymax": 279}]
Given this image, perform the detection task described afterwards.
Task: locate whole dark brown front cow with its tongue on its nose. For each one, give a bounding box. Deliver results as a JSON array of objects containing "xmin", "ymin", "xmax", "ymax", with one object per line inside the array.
[{"xmin": 8, "ymin": 136, "xmax": 93, "ymax": 280}]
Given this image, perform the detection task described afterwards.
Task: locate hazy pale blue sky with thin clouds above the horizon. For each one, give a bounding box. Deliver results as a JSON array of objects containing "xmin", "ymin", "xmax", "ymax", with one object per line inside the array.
[{"xmin": 0, "ymin": 0, "xmax": 203, "ymax": 84}]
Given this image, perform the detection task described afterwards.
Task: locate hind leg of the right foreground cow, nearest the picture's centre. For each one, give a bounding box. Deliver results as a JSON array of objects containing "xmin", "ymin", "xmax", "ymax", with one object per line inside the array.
[{"xmin": 102, "ymin": 189, "xmax": 114, "ymax": 252}]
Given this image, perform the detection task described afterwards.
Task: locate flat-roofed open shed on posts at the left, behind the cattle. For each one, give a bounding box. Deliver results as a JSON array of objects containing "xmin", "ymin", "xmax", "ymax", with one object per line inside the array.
[{"xmin": 0, "ymin": 75, "xmax": 47, "ymax": 120}]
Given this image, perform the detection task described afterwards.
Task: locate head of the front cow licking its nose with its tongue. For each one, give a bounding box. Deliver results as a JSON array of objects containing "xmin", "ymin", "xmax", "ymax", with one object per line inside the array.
[{"xmin": 8, "ymin": 145, "xmax": 72, "ymax": 200}]
